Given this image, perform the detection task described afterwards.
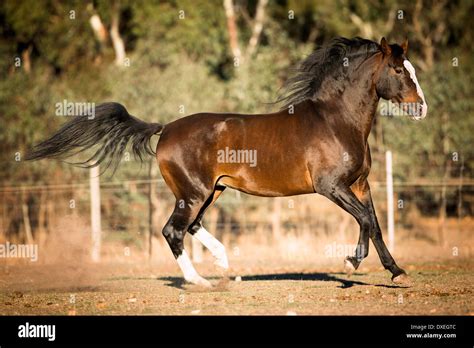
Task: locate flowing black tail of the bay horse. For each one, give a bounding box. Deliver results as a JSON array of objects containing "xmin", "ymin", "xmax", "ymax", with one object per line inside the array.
[{"xmin": 26, "ymin": 103, "xmax": 163, "ymax": 172}]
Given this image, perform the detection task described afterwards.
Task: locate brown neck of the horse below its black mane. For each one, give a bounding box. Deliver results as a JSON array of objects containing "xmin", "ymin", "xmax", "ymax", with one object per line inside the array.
[{"xmin": 316, "ymin": 58, "xmax": 380, "ymax": 140}]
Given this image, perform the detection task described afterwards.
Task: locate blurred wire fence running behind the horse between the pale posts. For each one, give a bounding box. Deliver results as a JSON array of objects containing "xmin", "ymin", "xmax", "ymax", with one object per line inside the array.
[{"xmin": 0, "ymin": 179, "xmax": 474, "ymax": 245}]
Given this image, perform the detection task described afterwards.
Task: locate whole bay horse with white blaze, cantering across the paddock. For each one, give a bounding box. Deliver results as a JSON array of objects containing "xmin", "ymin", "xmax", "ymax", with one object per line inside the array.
[{"xmin": 27, "ymin": 38, "xmax": 427, "ymax": 286}]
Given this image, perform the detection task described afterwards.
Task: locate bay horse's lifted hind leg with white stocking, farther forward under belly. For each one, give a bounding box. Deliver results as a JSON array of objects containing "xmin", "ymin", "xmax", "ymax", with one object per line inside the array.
[{"xmin": 188, "ymin": 185, "xmax": 229, "ymax": 270}]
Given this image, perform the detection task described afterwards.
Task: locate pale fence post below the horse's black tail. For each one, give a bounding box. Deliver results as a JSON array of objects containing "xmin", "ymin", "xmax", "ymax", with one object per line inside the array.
[{"xmin": 89, "ymin": 166, "xmax": 101, "ymax": 262}]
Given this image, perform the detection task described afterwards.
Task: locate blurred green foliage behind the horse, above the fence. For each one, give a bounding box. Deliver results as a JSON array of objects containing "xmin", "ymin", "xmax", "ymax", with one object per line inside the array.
[{"xmin": 0, "ymin": 0, "xmax": 474, "ymax": 198}]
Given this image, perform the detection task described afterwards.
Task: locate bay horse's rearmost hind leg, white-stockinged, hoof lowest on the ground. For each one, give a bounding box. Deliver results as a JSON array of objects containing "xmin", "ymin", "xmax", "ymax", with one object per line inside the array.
[{"xmin": 163, "ymin": 199, "xmax": 211, "ymax": 287}]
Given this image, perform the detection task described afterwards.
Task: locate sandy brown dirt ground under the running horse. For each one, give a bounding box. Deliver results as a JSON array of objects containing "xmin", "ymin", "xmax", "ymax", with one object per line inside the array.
[{"xmin": 0, "ymin": 253, "xmax": 474, "ymax": 315}]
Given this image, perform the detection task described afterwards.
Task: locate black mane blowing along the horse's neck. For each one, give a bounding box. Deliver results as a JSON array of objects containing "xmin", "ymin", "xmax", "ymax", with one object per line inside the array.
[{"xmin": 277, "ymin": 37, "xmax": 380, "ymax": 109}]
